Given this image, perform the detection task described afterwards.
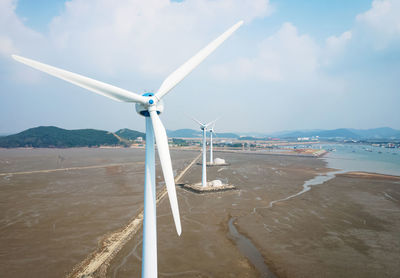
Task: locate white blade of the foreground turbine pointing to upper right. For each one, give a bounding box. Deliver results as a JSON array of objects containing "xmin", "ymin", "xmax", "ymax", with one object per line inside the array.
[{"xmin": 155, "ymin": 20, "xmax": 243, "ymax": 99}]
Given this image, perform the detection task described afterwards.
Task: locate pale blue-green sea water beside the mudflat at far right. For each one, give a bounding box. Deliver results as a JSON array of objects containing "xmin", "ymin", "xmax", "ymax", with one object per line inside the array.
[{"xmin": 321, "ymin": 144, "xmax": 400, "ymax": 176}]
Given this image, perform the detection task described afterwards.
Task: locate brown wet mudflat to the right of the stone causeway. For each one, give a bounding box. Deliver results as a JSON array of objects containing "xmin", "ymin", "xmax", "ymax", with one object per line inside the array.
[{"xmin": 107, "ymin": 153, "xmax": 400, "ymax": 277}]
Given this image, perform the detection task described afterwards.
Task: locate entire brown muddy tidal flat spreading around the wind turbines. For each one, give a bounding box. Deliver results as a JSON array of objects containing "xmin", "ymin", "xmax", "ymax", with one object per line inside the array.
[{"xmin": 0, "ymin": 149, "xmax": 400, "ymax": 277}]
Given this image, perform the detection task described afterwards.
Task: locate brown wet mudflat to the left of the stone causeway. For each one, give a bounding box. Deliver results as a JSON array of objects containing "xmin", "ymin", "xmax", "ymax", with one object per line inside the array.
[{"xmin": 0, "ymin": 148, "xmax": 197, "ymax": 277}]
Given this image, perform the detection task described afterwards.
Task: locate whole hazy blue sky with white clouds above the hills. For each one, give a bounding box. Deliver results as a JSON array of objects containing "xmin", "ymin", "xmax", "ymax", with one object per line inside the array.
[{"xmin": 0, "ymin": 0, "xmax": 400, "ymax": 134}]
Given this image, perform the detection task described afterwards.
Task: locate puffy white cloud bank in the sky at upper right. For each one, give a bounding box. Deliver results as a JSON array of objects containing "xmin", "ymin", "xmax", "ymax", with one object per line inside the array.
[{"xmin": 212, "ymin": 0, "xmax": 400, "ymax": 83}]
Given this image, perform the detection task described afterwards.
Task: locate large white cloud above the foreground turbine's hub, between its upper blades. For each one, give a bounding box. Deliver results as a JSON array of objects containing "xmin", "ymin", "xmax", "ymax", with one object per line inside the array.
[{"xmin": 42, "ymin": 0, "xmax": 272, "ymax": 77}]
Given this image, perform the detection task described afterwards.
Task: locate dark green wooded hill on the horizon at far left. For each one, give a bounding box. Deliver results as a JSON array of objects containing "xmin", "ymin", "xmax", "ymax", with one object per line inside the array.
[{"xmin": 0, "ymin": 126, "xmax": 124, "ymax": 148}]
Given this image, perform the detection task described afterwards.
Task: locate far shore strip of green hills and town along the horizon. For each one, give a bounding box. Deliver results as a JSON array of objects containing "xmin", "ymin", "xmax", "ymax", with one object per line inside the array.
[{"xmin": 0, "ymin": 126, "xmax": 400, "ymax": 148}]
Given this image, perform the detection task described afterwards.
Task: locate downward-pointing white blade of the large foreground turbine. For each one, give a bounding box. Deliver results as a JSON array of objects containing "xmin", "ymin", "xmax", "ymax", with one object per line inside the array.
[{"xmin": 150, "ymin": 111, "xmax": 182, "ymax": 235}]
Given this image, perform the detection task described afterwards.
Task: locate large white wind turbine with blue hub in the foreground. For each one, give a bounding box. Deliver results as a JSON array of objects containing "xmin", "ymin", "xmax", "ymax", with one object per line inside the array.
[{"xmin": 12, "ymin": 21, "xmax": 243, "ymax": 278}]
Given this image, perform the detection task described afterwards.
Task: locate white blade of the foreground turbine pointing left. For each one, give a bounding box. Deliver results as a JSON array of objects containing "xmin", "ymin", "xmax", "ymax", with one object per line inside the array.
[{"xmin": 12, "ymin": 55, "xmax": 147, "ymax": 103}]
